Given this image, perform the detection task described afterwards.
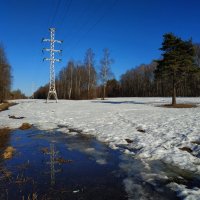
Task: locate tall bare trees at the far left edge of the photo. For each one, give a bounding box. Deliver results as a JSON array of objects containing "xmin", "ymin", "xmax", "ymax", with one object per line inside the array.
[{"xmin": 0, "ymin": 44, "xmax": 12, "ymax": 103}]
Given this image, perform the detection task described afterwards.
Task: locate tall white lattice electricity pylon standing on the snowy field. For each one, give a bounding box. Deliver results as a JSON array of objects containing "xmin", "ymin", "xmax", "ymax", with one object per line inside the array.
[{"xmin": 42, "ymin": 28, "xmax": 63, "ymax": 103}]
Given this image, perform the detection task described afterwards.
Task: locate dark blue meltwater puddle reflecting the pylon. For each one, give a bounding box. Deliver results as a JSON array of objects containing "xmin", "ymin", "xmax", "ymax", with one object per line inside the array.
[{"xmin": 0, "ymin": 130, "xmax": 176, "ymax": 200}]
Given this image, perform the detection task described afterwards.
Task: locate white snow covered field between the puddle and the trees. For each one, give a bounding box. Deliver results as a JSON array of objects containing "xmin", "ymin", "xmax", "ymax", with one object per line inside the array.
[{"xmin": 0, "ymin": 98, "xmax": 200, "ymax": 199}]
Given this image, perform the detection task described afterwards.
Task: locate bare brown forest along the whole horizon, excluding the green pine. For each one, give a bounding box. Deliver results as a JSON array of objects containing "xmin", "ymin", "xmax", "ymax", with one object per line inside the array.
[{"xmin": 0, "ymin": 33, "xmax": 200, "ymax": 102}]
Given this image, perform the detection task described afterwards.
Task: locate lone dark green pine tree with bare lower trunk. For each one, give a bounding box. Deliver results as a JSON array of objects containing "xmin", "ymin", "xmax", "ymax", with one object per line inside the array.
[{"xmin": 155, "ymin": 33, "xmax": 197, "ymax": 105}]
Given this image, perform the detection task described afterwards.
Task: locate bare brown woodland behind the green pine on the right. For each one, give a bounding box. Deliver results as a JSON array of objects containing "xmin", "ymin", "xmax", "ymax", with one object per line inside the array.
[{"xmin": 118, "ymin": 62, "xmax": 200, "ymax": 97}]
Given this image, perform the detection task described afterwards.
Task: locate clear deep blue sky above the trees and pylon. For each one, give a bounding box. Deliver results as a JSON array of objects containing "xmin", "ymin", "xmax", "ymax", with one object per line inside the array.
[{"xmin": 0, "ymin": 0, "xmax": 200, "ymax": 95}]
